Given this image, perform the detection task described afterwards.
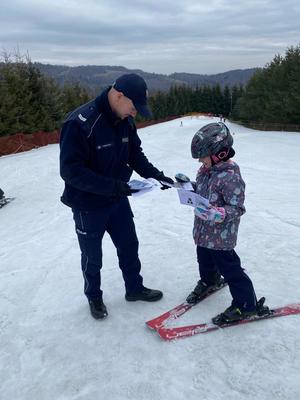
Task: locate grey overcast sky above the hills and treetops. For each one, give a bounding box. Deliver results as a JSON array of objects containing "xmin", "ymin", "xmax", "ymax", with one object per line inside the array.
[{"xmin": 0, "ymin": 0, "xmax": 300, "ymax": 74}]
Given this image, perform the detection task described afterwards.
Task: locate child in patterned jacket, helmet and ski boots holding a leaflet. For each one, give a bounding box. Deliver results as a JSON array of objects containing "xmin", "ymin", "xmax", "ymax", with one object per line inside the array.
[{"xmin": 186, "ymin": 122, "xmax": 269, "ymax": 325}]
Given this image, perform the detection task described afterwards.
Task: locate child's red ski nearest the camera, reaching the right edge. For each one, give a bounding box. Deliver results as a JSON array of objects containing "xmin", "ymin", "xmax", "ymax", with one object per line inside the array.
[{"xmin": 157, "ymin": 303, "xmax": 300, "ymax": 340}]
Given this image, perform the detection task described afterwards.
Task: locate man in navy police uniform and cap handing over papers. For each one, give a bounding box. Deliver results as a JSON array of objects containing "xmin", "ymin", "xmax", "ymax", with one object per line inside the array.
[{"xmin": 60, "ymin": 74, "xmax": 173, "ymax": 319}]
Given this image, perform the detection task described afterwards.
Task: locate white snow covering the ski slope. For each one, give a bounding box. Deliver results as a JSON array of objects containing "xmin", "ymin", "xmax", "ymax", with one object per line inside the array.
[{"xmin": 0, "ymin": 117, "xmax": 300, "ymax": 400}]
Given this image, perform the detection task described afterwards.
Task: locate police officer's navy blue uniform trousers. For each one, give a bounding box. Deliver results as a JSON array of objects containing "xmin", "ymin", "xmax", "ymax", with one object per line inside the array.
[{"xmin": 72, "ymin": 197, "xmax": 143, "ymax": 299}]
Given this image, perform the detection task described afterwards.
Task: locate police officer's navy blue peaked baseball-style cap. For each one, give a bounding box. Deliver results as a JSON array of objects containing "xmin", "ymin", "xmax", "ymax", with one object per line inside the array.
[{"xmin": 113, "ymin": 74, "xmax": 152, "ymax": 117}]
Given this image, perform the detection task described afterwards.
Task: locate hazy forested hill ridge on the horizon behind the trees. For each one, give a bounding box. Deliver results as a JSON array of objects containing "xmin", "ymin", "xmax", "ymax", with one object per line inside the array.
[{"xmin": 35, "ymin": 63, "xmax": 258, "ymax": 93}]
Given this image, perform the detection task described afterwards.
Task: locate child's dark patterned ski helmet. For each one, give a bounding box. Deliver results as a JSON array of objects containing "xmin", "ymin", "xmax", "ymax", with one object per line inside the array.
[{"xmin": 191, "ymin": 122, "xmax": 233, "ymax": 158}]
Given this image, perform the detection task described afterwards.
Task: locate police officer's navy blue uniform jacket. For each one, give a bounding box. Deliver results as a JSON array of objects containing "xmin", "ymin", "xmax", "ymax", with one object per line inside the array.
[{"xmin": 60, "ymin": 88, "xmax": 160, "ymax": 210}]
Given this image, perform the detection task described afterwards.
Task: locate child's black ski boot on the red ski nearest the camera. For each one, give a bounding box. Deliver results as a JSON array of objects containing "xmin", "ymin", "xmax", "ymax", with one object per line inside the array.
[{"xmin": 212, "ymin": 297, "xmax": 271, "ymax": 326}]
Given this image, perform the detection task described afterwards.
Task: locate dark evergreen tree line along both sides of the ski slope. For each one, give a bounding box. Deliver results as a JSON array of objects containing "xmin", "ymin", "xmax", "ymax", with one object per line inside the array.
[{"xmin": 0, "ymin": 45, "xmax": 300, "ymax": 136}]
